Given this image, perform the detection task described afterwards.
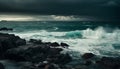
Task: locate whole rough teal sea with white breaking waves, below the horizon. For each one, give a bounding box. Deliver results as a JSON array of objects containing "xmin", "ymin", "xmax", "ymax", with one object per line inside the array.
[{"xmin": 0, "ymin": 22, "xmax": 120, "ymax": 58}]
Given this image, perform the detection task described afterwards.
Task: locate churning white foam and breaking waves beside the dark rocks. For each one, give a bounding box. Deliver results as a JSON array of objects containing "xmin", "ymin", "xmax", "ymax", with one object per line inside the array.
[{"xmin": 7, "ymin": 27, "xmax": 120, "ymax": 56}]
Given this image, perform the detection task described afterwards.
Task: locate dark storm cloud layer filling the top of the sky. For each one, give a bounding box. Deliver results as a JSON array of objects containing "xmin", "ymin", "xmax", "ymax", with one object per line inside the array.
[{"xmin": 0, "ymin": 0, "xmax": 120, "ymax": 20}]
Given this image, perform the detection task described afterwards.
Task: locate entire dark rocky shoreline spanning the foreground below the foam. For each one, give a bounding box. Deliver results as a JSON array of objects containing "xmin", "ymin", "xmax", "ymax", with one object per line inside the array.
[{"xmin": 0, "ymin": 33, "xmax": 120, "ymax": 69}]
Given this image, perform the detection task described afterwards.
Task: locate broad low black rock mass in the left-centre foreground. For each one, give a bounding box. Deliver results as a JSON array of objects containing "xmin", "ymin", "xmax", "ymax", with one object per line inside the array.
[{"xmin": 6, "ymin": 45, "xmax": 71, "ymax": 64}]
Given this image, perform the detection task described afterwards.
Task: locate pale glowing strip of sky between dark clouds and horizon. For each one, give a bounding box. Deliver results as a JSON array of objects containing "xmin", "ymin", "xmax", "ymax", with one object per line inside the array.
[{"xmin": 0, "ymin": 15, "xmax": 96, "ymax": 21}]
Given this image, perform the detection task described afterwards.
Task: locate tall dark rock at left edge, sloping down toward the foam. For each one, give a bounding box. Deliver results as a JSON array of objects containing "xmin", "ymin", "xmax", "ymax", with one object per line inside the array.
[{"xmin": 0, "ymin": 33, "xmax": 26, "ymax": 58}]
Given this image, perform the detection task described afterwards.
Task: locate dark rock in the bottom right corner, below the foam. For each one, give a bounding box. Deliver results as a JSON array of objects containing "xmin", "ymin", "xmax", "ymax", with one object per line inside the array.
[{"xmin": 97, "ymin": 57, "xmax": 120, "ymax": 69}]
